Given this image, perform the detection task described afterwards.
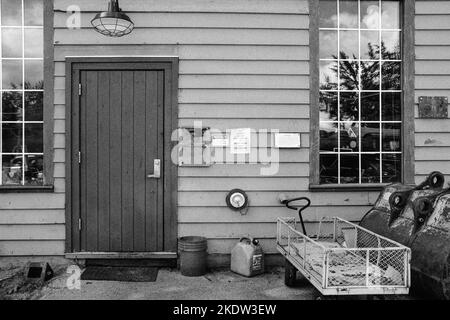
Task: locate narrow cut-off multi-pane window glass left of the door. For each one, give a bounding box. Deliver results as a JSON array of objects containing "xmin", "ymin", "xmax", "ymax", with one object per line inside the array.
[{"xmin": 0, "ymin": 0, "xmax": 44, "ymax": 186}]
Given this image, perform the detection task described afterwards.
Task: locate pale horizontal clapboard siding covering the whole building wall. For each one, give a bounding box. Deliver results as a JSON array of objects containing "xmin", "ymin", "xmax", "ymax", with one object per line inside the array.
[{"xmin": 6, "ymin": 0, "xmax": 450, "ymax": 256}]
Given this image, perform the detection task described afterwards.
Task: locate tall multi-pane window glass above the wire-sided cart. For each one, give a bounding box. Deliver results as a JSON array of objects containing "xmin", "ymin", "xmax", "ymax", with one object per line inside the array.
[{"xmin": 319, "ymin": 0, "xmax": 402, "ymax": 184}]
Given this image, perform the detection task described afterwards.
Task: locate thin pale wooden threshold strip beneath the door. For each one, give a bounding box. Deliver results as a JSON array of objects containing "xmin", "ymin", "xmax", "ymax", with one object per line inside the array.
[{"xmin": 65, "ymin": 252, "xmax": 178, "ymax": 259}]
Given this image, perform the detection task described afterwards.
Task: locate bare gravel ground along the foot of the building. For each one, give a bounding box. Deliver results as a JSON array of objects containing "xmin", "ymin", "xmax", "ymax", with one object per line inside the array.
[{"xmin": 0, "ymin": 268, "xmax": 411, "ymax": 300}]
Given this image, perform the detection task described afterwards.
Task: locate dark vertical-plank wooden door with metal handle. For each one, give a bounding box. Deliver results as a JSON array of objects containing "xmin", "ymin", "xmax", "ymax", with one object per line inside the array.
[{"xmin": 79, "ymin": 68, "xmax": 164, "ymax": 252}]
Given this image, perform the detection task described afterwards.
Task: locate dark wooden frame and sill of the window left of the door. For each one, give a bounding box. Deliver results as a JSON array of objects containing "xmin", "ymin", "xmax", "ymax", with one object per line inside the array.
[{"xmin": 0, "ymin": 0, "xmax": 54, "ymax": 193}]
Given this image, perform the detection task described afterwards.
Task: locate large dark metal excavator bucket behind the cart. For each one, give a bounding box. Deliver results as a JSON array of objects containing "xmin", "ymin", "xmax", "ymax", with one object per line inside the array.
[{"xmin": 360, "ymin": 172, "xmax": 450, "ymax": 299}]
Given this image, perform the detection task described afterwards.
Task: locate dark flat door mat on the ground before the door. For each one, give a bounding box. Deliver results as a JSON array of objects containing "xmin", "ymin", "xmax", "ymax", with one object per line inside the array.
[{"xmin": 81, "ymin": 266, "xmax": 158, "ymax": 282}]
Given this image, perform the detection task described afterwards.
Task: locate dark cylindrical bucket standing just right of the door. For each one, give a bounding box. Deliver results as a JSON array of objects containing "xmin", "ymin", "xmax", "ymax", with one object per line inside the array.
[{"xmin": 178, "ymin": 237, "xmax": 207, "ymax": 277}]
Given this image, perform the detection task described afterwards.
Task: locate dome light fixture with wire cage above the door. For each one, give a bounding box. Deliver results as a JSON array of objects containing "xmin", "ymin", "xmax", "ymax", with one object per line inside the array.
[{"xmin": 91, "ymin": 0, "xmax": 134, "ymax": 37}]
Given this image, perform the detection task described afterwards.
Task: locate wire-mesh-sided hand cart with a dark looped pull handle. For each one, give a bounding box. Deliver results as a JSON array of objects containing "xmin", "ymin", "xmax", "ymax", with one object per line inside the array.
[{"xmin": 277, "ymin": 198, "xmax": 411, "ymax": 296}]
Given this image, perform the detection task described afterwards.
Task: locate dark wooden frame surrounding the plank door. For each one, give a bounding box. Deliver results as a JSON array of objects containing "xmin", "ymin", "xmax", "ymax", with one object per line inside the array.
[{"xmin": 65, "ymin": 56, "xmax": 179, "ymax": 259}]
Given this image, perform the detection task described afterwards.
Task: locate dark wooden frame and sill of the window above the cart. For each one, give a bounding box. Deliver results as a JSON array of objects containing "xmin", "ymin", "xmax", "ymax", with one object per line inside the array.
[{"xmin": 309, "ymin": 0, "xmax": 415, "ymax": 191}]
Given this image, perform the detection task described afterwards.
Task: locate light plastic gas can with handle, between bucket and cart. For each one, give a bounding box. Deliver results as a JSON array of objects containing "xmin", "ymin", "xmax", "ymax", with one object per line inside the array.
[{"xmin": 231, "ymin": 237, "xmax": 264, "ymax": 277}]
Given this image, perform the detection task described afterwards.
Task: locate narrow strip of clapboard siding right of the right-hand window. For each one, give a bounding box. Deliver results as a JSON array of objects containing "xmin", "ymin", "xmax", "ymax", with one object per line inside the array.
[{"xmin": 415, "ymin": 1, "xmax": 450, "ymax": 188}]
